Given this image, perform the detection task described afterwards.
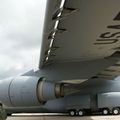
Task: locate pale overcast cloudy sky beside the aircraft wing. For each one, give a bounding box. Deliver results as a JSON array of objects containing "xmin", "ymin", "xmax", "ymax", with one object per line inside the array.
[{"xmin": 0, "ymin": 0, "xmax": 46, "ymax": 79}]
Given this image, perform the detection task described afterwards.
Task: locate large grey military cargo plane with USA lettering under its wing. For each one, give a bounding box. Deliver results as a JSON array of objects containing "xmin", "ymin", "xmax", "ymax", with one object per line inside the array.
[{"xmin": 0, "ymin": 0, "xmax": 120, "ymax": 116}]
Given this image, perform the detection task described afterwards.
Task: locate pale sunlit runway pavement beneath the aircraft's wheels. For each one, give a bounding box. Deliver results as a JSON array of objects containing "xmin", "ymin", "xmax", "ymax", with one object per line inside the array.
[{"xmin": 7, "ymin": 115, "xmax": 120, "ymax": 120}]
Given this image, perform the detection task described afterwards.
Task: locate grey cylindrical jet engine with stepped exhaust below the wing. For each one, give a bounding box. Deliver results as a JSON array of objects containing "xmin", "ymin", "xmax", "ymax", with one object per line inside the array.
[{"xmin": 0, "ymin": 76, "xmax": 63, "ymax": 107}]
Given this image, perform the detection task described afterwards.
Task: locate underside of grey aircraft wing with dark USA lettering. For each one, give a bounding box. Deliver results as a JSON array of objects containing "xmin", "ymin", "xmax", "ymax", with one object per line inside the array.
[{"xmin": 39, "ymin": 0, "xmax": 120, "ymax": 79}]
